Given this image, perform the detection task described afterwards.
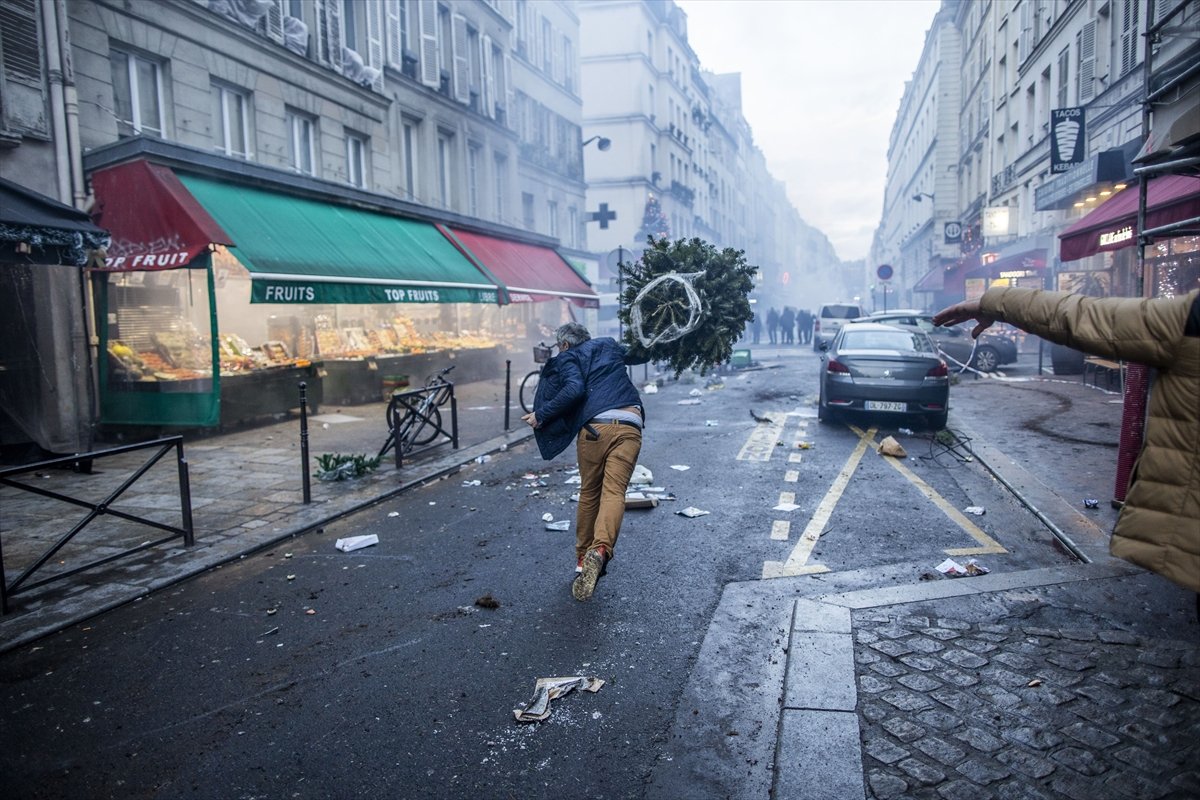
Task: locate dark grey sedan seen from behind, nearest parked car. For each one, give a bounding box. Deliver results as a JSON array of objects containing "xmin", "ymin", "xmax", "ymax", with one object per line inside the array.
[{"xmin": 817, "ymin": 321, "xmax": 950, "ymax": 431}]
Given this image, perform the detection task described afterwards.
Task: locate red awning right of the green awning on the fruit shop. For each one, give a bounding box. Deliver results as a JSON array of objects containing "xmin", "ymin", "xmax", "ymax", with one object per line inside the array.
[{"xmin": 438, "ymin": 225, "xmax": 600, "ymax": 308}]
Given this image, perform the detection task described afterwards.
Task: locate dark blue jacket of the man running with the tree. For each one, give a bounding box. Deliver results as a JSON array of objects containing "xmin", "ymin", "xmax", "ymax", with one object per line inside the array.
[{"xmin": 533, "ymin": 337, "xmax": 646, "ymax": 461}]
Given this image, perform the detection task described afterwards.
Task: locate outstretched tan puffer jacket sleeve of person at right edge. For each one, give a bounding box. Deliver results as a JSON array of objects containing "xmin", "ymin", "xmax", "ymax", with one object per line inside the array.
[{"xmin": 980, "ymin": 288, "xmax": 1196, "ymax": 367}]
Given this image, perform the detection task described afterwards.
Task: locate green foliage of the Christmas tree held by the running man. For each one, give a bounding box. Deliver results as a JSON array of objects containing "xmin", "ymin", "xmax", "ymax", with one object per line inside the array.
[{"xmin": 620, "ymin": 236, "xmax": 757, "ymax": 377}]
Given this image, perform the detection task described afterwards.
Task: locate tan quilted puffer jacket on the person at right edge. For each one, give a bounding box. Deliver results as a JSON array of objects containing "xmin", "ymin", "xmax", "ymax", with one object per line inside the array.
[{"xmin": 980, "ymin": 289, "xmax": 1200, "ymax": 593}]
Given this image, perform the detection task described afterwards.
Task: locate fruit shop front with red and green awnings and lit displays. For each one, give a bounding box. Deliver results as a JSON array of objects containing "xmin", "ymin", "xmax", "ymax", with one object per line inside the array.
[{"xmin": 92, "ymin": 160, "xmax": 598, "ymax": 427}]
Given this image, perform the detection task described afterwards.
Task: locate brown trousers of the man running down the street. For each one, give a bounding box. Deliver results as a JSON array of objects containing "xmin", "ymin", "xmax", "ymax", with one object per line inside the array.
[{"xmin": 575, "ymin": 422, "xmax": 642, "ymax": 559}]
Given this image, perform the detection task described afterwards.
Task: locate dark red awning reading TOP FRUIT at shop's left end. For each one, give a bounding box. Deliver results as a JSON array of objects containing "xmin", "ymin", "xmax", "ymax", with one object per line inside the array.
[{"xmin": 91, "ymin": 161, "xmax": 233, "ymax": 272}]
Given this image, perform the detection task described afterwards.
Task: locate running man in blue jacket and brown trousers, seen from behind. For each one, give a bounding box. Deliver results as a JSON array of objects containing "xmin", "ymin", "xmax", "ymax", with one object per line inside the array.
[{"xmin": 521, "ymin": 323, "xmax": 646, "ymax": 600}]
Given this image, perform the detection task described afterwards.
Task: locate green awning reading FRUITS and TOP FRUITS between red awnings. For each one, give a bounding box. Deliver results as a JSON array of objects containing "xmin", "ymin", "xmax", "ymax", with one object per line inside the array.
[{"xmin": 179, "ymin": 174, "xmax": 499, "ymax": 303}]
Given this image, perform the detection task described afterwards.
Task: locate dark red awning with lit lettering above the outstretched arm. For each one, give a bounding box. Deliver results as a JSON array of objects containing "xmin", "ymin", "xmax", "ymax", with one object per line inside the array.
[{"xmin": 1058, "ymin": 175, "xmax": 1200, "ymax": 261}]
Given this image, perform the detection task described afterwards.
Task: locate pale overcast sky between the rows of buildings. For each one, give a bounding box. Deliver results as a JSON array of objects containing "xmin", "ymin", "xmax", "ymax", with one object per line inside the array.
[{"xmin": 677, "ymin": 0, "xmax": 940, "ymax": 260}]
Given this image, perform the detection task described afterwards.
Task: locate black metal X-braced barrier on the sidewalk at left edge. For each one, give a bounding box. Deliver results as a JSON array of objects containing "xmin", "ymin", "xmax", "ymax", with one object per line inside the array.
[{"xmin": 0, "ymin": 437, "xmax": 194, "ymax": 614}]
